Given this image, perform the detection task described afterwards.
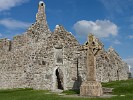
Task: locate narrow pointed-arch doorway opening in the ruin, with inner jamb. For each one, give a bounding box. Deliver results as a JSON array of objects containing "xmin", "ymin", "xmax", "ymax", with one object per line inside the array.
[{"xmin": 55, "ymin": 68, "xmax": 64, "ymax": 90}]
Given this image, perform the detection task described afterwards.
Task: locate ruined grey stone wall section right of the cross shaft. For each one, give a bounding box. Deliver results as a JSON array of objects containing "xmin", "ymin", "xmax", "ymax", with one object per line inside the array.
[{"xmin": 97, "ymin": 48, "xmax": 128, "ymax": 82}]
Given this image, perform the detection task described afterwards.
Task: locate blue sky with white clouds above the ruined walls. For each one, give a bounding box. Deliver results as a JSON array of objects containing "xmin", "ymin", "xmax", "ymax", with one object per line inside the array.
[{"xmin": 0, "ymin": 0, "xmax": 133, "ymax": 66}]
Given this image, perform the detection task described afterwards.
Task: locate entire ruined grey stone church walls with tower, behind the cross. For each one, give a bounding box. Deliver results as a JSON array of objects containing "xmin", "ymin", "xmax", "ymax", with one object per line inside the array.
[{"xmin": 0, "ymin": 1, "xmax": 128, "ymax": 90}]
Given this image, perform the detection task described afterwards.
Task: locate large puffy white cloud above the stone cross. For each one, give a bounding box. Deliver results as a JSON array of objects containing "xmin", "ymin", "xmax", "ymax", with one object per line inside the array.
[{"xmin": 73, "ymin": 20, "xmax": 118, "ymax": 38}]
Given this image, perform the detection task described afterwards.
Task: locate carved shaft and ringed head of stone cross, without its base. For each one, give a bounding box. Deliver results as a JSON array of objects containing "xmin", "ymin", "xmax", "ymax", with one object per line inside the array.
[{"xmin": 83, "ymin": 34, "xmax": 103, "ymax": 81}]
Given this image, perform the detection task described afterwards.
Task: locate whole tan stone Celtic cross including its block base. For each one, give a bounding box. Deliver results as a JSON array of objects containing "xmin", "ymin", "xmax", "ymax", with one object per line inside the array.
[{"xmin": 80, "ymin": 34, "xmax": 103, "ymax": 97}]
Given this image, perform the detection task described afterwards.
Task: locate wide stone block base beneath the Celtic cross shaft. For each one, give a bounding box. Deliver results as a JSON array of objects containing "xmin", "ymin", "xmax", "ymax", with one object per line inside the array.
[{"xmin": 80, "ymin": 81, "xmax": 103, "ymax": 97}]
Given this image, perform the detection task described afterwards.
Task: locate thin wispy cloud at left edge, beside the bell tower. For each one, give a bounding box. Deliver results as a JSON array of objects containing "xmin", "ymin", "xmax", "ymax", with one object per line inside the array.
[{"xmin": 0, "ymin": 18, "xmax": 31, "ymax": 29}]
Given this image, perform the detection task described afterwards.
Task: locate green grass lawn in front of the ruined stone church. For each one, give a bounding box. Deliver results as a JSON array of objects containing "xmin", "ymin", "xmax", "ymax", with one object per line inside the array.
[{"xmin": 0, "ymin": 80, "xmax": 133, "ymax": 100}]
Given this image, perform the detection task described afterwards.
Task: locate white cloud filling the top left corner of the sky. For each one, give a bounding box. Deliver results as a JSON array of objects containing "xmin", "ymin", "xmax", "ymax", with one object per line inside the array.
[{"xmin": 0, "ymin": 0, "xmax": 29, "ymax": 11}]
